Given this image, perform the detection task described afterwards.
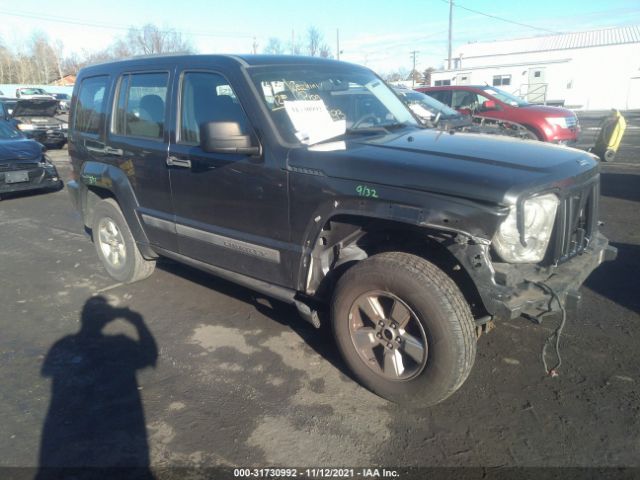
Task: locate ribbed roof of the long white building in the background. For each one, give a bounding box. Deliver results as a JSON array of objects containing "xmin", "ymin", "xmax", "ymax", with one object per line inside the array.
[{"xmin": 454, "ymin": 25, "xmax": 640, "ymax": 58}]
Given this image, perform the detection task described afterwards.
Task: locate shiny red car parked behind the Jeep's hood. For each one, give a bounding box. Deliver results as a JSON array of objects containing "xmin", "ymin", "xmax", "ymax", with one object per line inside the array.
[{"xmin": 416, "ymin": 85, "xmax": 580, "ymax": 145}]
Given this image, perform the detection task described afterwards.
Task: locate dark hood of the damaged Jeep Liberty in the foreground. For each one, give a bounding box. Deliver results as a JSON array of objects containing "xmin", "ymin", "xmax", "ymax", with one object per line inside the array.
[{"xmin": 289, "ymin": 130, "xmax": 598, "ymax": 205}]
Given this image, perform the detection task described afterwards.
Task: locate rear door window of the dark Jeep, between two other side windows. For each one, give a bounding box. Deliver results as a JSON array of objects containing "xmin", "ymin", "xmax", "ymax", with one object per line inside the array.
[{"xmin": 111, "ymin": 73, "xmax": 169, "ymax": 139}]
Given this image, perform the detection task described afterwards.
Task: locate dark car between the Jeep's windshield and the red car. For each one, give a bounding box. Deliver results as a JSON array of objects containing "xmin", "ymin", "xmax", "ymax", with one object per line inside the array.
[{"xmin": 394, "ymin": 87, "xmax": 536, "ymax": 139}]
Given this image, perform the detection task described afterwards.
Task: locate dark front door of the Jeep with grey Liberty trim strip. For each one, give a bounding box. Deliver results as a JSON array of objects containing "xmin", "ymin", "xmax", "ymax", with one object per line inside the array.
[{"xmin": 167, "ymin": 71, "xmax": 290, "ymax": 285}]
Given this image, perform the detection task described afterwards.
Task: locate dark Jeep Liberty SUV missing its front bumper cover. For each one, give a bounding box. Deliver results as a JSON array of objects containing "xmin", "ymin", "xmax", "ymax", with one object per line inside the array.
[{"xmin": 68, "ymin": 55, "xmax": 616, "ymax": 405}]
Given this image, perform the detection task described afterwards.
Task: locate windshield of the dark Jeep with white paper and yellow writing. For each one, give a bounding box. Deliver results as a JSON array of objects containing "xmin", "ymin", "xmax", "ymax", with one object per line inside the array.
[{"xmin": 250, "ymin": 65, "xmax": 418, "ymax": 145}]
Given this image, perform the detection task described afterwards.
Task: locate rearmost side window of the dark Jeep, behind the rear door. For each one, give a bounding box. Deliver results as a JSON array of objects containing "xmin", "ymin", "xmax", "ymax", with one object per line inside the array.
[{"xmin": 75, "ymin": 76, "xmax": 108, "ymax": 134}]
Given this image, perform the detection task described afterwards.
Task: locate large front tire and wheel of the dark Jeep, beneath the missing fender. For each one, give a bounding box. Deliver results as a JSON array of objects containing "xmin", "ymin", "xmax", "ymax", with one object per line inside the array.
[{"xmin": 331, "ymin": 252, "xmax": 476, "ymax": 406}]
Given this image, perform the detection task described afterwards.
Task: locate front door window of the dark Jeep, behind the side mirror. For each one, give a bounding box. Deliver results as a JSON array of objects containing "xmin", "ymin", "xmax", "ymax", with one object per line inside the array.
[{"xmin": 179, "ymin": 72, "xmax": 247, "ymax": 144}]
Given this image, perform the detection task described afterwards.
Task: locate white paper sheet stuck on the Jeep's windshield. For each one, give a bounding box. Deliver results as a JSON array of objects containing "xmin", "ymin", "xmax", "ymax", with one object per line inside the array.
[{"xmin": 284, "ymin": 100, "xmax": 347, "ymax": 145}]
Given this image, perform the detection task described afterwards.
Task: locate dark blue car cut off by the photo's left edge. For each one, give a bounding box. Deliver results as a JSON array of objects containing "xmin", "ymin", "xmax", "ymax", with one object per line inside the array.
[{"xmin": 0, "ymin": 120, "xmax": 62, "ymax": 196}]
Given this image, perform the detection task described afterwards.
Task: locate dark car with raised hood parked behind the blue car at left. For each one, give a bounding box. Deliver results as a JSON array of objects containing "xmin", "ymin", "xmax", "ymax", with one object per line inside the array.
[{"xmin": 11, "ymin": 98, "xmax": 69, "ymax": 148}]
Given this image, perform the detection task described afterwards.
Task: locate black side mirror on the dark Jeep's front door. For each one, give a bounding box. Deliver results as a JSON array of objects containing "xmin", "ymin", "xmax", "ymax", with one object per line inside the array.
[{"xmin": 200, "ymin": 122, "xmax": 261, "ymax": 155}]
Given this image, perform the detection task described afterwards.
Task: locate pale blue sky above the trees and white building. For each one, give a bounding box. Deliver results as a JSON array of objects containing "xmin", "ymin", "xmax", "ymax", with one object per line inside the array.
[{"xmin": 0, "ymin": 0, "xmax": 640, "ymax": 73}]
